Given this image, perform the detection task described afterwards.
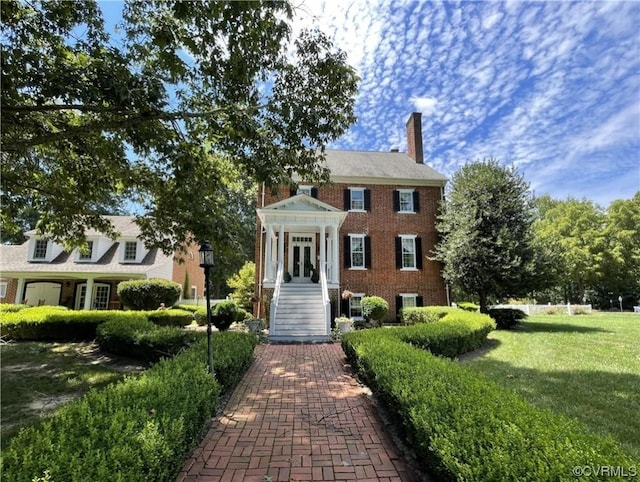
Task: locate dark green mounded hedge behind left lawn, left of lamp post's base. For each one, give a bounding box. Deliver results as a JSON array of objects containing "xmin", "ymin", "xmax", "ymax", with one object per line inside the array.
[{"xmin": 96, "ymin": 312, "xmax": 204, "ymax": 362}]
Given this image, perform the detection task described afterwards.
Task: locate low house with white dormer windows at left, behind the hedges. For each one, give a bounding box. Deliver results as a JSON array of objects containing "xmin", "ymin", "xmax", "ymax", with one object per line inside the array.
[{"xmin": 0, "ymin": 216, "xmax": 204, "ymax": 310}]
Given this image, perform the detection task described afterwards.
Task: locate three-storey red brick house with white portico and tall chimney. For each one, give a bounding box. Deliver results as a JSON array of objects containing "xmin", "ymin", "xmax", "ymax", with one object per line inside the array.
[{"xmin": 256, "ymin": 113, "xmax": 448, "ymax": 340}]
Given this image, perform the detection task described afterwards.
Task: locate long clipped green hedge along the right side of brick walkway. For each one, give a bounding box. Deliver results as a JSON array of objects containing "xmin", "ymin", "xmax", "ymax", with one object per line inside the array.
[{"xmin": 342, "ymin": 328, "xmax": 634, "ymax": 482}]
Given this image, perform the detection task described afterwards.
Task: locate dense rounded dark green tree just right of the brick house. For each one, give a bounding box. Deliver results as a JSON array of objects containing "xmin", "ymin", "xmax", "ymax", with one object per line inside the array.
[{"xmin": 434, "ymin": 159, "xmax": 546, "ymax": 312}]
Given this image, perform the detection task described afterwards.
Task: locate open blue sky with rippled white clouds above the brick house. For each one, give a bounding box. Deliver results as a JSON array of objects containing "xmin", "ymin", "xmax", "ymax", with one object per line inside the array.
[{"xmin": 297, "ymin": 0, "xmax": 640, "ymax": 207}]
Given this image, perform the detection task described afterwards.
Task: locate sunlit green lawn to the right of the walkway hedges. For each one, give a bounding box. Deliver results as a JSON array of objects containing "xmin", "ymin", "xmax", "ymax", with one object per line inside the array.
[{"xmin": 461, "ymin": 313, "xmax": 640, "ymax": 461}]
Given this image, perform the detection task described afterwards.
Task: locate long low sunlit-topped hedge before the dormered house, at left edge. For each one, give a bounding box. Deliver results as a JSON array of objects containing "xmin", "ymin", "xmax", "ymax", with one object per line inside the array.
[{"xmin": 0, "ymin": 306, "xmax": 146, "ymax": 341}]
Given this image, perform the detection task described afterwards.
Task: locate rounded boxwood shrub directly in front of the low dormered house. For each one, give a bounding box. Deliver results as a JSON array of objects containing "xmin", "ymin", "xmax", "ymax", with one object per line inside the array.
[{"xmin": 118, "ymin": 278, "xmax": 182, "ymax": 310}]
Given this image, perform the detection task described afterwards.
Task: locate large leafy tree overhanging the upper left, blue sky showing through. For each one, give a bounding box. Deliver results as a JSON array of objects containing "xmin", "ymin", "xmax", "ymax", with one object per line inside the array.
[{"xmin": 0, "ymin": 0, "xmax": 357, "ymax": 252}]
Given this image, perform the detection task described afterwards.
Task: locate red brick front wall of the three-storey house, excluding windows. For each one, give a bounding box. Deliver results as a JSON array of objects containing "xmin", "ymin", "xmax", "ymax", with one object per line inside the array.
[{"xmin": 256, "ymin": 183, "xmax": 447, "ymax": 321}]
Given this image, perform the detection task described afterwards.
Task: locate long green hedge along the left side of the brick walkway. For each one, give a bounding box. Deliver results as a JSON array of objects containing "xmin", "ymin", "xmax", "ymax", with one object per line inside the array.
[{"xmin": 2, "ymin": 333, "xmax": 255, "ymax": 482}]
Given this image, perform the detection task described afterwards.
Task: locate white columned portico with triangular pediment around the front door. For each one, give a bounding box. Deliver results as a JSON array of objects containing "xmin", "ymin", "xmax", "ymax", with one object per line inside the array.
[{"xmin": 258, "ymin": 194, "xmax": 347, "ymax": 288}]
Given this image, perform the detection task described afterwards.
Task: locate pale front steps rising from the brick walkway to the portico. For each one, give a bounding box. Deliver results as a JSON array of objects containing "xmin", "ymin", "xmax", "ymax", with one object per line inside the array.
[{"xmin": 269, "ymin": 283, "xmax": 331, "ymax": 342}]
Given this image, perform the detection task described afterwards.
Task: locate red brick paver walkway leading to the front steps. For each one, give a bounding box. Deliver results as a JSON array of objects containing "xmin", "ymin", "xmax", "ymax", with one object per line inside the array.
[{"xmin": 177, "ymin": 344, "xmax": 416, "ymax": 482}]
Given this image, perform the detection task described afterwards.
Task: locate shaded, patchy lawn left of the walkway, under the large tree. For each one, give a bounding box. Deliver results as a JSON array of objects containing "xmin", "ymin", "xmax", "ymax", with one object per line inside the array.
[{"xmin": 0, "ymin": 342, "xmax": 143, "ymax": 447}]
